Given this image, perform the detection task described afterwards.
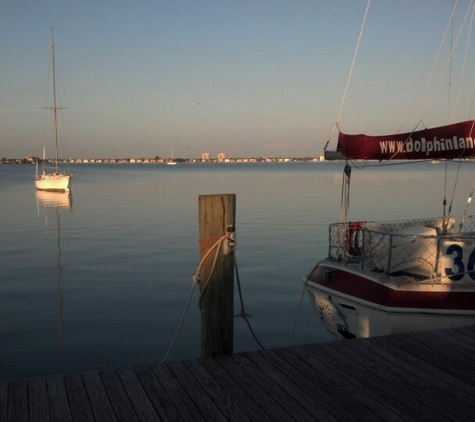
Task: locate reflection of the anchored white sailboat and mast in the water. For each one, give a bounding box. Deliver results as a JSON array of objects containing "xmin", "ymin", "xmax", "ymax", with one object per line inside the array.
[{"xmin": 36, "ymin": 191, "xmax": 73, "ymax": 348}]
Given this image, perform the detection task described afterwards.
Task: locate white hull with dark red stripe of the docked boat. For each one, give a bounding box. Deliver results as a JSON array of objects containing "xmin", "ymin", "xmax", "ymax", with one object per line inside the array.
[{"xmin": 305, "ymin": 263, "xmax": 475, "ymax": 339}]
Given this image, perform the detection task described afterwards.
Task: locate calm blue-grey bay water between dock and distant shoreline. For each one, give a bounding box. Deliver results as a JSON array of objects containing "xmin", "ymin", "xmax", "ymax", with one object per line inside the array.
[{"xmin": 0, "ymin": 163, "xmax": 475, "ymax": 380}]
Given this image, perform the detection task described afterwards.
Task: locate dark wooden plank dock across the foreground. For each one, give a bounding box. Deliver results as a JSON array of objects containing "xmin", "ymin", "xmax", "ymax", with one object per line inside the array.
[{"xmin": 0, "ymin": 327, "xmax": 475, "ymax": 422}]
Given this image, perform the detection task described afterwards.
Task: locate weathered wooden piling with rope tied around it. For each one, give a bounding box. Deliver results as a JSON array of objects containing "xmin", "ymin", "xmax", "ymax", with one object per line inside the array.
[{"xmin": 199, "ymin": 194, "xmax": 236, "ymax": 357}]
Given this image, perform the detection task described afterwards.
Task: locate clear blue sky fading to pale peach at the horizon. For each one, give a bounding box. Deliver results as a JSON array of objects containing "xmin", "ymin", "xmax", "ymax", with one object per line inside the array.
[{"xmin": 0, "ymin": 0, "xmax": 474, "ymax": 158}]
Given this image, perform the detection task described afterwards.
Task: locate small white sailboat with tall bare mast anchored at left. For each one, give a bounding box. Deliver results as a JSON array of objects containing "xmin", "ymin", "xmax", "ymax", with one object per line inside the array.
[{"xmin": 35, "ymin": 28, "xmax": 72, "ymax": 192}]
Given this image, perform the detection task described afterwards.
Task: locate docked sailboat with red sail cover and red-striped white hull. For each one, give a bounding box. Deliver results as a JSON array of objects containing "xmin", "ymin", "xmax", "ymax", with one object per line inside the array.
[{"xmin": 304, "ymin": 2, "xmax": 475, "ymax": 339}]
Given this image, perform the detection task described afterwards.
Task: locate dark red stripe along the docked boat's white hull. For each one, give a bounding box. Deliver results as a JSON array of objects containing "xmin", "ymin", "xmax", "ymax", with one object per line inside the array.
[{"xmin": 308, "ymin": 264, "xmax": 475, "ymax": 310}]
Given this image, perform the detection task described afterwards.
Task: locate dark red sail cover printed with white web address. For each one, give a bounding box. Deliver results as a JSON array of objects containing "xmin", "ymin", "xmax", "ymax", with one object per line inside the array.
[{"xmin": 337, "ymin": 120, "xmax": 475, "ymax": 160}]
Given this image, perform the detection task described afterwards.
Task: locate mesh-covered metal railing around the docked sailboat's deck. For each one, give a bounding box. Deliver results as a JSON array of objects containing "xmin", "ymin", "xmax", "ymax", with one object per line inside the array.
[{"xmin": 328, "ymin": 216, "xmax": 475, "ymax": 278}]
